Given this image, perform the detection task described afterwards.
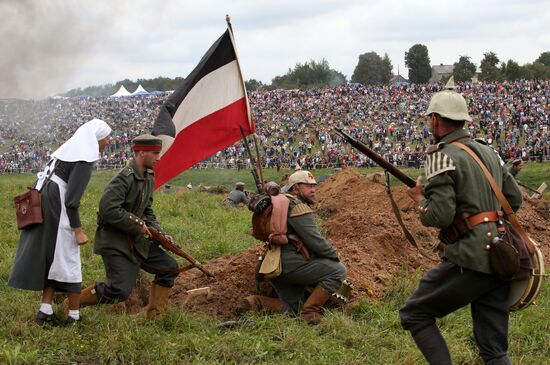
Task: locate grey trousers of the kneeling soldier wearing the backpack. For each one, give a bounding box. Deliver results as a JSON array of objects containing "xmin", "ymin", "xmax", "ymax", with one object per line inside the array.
[{"xmin": 271, "ymin": 258, "xmax": 347, "ymax": 314}]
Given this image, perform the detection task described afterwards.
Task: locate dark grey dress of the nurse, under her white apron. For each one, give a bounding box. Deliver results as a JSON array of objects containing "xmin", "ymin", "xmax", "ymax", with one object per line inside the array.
[{"xmin": 8, "ymin": 161, "xmax": 93, "ymax": 292}]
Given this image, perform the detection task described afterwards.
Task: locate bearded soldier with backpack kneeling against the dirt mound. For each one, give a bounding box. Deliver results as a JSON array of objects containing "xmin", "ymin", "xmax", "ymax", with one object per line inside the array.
[{"xmin": 240, "ymin": 170, "xmax": 347, "ymax": 324}]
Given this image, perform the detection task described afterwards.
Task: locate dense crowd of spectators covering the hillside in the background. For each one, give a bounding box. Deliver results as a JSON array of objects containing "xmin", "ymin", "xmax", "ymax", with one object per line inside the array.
[{"xmin": 0, "ymin": 80, "xmax": 550, "ymax": 172}]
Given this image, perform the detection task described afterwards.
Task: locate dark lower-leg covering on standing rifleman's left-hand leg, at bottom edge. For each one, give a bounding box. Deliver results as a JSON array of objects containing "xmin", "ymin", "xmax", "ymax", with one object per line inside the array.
[{"xmin": 411, "ymin": 324, "xmax": 452, "ymax": 365}]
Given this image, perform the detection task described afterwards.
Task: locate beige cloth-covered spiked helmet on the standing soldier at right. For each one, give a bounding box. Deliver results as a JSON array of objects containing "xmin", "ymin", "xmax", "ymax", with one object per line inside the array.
[{"xmin": 424, "ymin": 76, "xmax": 472, "ymax": 122}]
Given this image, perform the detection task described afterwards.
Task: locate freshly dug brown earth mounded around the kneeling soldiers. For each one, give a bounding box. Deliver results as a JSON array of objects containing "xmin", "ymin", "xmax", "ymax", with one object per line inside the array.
[{"xmin": 118, "ymin": 169, "xmax": 550, "ymax": 319}]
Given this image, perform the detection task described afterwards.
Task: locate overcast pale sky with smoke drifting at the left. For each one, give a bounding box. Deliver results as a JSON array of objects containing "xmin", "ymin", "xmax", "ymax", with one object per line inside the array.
[{"xmin": 0, "ymin": 0, "xmax": 550, "ymax": 98}]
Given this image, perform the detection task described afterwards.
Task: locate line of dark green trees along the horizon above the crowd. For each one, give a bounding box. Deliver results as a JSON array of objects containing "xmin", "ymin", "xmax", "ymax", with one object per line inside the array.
[{"xmin": 64, "ymin": 44, "xmax": 550, "ymax": 96}]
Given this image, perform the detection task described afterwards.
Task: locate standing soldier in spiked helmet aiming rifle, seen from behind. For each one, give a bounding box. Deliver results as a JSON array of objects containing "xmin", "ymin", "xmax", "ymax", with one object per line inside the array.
[{"xmin": 399, "ymin": 78, "xmax": 522, "ymax": 365}]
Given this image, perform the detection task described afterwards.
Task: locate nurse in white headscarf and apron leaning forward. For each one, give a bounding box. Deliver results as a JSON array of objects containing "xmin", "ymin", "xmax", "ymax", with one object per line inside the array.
[{"xmin": 8, "ymin": 119, "xmax": 111, "ymax": 325}]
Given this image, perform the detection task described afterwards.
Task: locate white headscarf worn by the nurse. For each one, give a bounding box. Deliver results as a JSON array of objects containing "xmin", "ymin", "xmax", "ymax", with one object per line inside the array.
[{"xmin": 52, "ymin": 118, "xmax": 111, "ymax": 162}]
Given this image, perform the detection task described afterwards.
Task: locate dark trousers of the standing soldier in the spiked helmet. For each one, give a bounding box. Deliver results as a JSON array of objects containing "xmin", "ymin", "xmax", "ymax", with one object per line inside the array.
[{"xmin": 399, "ymin": 261, "xmax": 511, "ymax": 364}]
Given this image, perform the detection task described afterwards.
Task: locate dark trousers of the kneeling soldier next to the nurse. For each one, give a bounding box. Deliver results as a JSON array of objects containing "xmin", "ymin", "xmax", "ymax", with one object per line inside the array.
[{"xmin": 96, "ymin": 245, "xmax": 178, "ymax": 303}]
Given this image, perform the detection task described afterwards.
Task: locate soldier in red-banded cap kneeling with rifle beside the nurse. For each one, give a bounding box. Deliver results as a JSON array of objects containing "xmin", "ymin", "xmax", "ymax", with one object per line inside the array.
[{"xmin": 62, "ymin": 134, "xmax": 178, "ymax": 318}]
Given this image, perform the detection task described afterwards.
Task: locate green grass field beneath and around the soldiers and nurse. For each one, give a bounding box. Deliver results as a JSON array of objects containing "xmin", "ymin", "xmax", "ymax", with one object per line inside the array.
[{"xmin": 0, "ymin": 164, "xmax": 550, "ymax": 365}]
